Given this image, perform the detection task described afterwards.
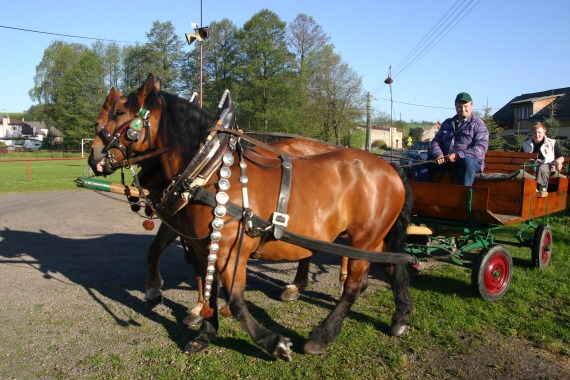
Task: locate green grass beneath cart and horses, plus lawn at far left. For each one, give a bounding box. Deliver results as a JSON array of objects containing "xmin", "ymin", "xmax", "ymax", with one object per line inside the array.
[{"xmin": 0, "ymin": 160, "xmax": 570, "ymax": 380}]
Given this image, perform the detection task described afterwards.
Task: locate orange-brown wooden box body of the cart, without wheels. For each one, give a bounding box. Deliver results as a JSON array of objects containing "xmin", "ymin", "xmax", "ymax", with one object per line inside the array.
[{"xmin": 410, "ymin": 151, "xmax": 568, "ymax": 225}]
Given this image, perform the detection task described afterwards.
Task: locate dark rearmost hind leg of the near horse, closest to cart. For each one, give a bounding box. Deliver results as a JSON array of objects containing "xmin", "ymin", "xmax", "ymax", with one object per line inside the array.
[{"xmin": 382, "ymin": 264, "xmax": 412, "ymax": 336}]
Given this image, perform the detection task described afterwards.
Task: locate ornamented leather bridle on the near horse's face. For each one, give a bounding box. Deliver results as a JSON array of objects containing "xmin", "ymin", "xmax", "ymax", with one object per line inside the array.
[{"xmin": 97, "ymin": 98, "xmax": 168, "ymax": 169}]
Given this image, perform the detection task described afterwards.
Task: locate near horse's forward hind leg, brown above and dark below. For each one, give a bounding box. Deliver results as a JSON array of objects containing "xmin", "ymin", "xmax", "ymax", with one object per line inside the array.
[{"xmin": 303, "ymin": 259, "xmax": 370, "ymax": 354}]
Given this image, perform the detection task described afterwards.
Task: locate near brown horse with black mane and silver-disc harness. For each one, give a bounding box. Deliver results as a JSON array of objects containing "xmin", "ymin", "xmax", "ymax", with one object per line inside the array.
[{"xmin": 89, "ymin": 75, "xmax": 414, "ymax": 360}]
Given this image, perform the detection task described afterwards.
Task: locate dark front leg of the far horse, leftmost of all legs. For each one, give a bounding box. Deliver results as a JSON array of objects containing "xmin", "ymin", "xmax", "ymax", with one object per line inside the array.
[{"xmin": 145, "ymin": 223, "xmax": 178, "ymax": 310}]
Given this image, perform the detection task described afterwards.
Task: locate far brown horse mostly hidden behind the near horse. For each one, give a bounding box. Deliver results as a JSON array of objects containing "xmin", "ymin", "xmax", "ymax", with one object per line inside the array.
[{"xmin": 91, "ymin": 87, "xmax": 338, "ymax": 326}]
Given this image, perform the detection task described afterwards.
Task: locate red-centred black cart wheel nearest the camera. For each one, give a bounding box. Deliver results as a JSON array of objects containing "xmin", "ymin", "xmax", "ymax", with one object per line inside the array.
[{"xmin": 471, "ymin": 245, "xmax": 513, "ymax": 301}]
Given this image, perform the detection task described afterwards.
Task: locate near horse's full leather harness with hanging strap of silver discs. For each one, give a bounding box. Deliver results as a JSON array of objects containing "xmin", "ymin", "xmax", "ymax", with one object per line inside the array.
[{"xmin": 104, "ymin": 90, "xmax": 416, "ymax": 303}]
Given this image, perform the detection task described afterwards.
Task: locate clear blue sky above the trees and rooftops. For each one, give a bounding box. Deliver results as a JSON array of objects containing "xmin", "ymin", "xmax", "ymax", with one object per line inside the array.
[{"xmin": 0, "ymin": 0, "xmax": 570, "ymax": 122}]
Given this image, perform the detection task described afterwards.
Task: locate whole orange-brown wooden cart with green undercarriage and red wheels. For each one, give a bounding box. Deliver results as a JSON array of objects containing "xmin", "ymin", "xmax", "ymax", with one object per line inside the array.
[{"xmin": 407, "ymin": 151, "xmax": 568, "ymax": 301}]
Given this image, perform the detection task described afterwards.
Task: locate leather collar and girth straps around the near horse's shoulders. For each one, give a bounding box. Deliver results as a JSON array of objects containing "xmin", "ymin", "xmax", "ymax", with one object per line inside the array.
[{"xmin": 148, "ymin": 92, "xmax": 292, "ymax": 252}]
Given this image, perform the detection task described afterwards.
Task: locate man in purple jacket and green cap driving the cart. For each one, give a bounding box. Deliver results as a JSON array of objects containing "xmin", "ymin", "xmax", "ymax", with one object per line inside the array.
[{"xmin": 414, "ymin": 92, "xmax": 489, "ymax": 186}]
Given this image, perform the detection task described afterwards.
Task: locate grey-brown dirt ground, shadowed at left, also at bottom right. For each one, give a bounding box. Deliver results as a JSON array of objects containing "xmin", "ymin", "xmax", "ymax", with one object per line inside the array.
[{"xmin": 0, "ymin": 190, "xmax": 570, "ymax": 379}]
